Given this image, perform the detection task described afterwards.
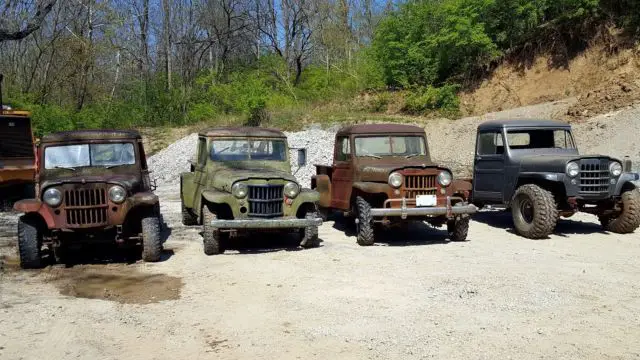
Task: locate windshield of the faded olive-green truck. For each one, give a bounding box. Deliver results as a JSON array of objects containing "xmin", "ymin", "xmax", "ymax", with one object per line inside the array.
[{"xmin": 211, "ymin": 139, "xmax": 287, "ymax": 161}]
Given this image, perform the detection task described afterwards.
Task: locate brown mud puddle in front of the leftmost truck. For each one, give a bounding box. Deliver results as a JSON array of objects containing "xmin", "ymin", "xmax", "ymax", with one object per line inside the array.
[{"xmin": 45, "ymin": 265, "xmax": 184, "ymax": 304}]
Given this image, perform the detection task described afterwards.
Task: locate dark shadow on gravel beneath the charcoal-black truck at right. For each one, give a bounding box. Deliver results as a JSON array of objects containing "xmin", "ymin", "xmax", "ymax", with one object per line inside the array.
[{"xmin": 472, "ymin": 210, "xmax": 609, "ymax": 237}]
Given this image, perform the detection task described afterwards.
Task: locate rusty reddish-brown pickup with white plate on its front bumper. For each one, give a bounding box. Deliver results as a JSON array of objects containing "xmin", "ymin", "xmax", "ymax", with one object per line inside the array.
[{"xmin": 311, "ymin": 124, "xmax": 477, "ymax": 245}]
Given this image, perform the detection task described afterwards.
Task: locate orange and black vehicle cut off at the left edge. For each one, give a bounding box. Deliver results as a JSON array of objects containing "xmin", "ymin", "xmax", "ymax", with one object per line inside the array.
[{"xmin": 0, "ymin": 75, "xmax": 36, "ymax": 205}]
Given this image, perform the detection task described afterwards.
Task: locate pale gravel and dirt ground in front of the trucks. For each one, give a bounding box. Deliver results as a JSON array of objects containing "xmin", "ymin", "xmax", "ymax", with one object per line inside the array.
[{"xmin": 0, "ymin": 188, "xmax": 640, "ymax": 359}]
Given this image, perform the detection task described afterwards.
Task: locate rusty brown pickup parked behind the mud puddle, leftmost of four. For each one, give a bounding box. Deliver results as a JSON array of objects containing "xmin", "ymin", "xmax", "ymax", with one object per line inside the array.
[{"xmin": 14, "ymin": 130, "xmax": 162, "ymax": 267}]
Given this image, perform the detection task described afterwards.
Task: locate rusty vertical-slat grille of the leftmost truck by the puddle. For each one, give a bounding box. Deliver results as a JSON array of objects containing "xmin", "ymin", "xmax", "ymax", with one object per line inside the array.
[{"xmin": 64, "ymin": 189, "xmax": 108, "ymax": 226}]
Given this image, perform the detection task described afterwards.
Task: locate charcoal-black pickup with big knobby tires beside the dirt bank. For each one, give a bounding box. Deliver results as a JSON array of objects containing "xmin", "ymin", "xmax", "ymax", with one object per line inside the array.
[{"xmin": 472, "ymin": 120, "xmax": 640, "ymax": 239}]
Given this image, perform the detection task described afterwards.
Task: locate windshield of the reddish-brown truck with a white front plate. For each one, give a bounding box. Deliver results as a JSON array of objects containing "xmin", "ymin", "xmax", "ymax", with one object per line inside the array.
[{"xmin": 355, "ymin": 136, "xmax": 427, "ymax": 156}]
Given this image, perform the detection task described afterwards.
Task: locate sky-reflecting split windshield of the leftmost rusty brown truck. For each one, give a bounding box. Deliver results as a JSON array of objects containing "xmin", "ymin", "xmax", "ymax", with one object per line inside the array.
[{"xmin": 44, "ymin": 143, "xmax": 136, "ymax": 169}]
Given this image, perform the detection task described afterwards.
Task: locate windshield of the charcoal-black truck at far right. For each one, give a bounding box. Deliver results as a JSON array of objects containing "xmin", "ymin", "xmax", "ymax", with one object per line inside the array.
[{"xmin": 507, "ymin": 129, "xmax": 576, "ymax": 150}]
